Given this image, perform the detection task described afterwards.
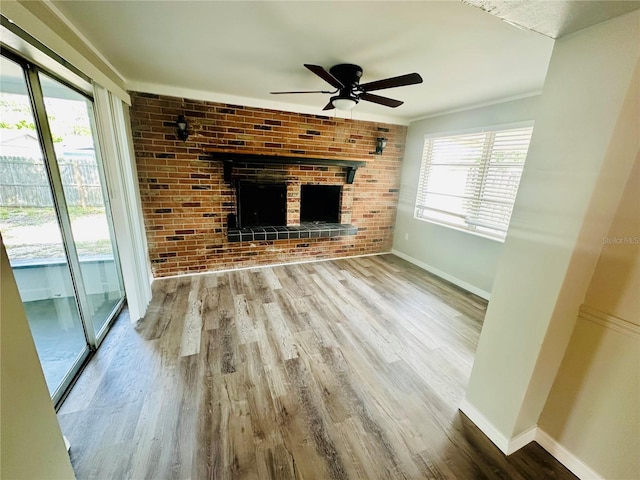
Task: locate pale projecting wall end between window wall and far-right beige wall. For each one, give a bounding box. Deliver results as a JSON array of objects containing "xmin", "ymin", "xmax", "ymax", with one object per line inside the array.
[{"xmin": 463, "ymin": 12, "xmax": 640, "ymax": 451}]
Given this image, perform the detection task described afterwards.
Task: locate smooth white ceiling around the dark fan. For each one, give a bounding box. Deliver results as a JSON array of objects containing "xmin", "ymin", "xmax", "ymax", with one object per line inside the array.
[{"xmin": 50, "ymin": 0, "xmax": 636, "ymax": 123}]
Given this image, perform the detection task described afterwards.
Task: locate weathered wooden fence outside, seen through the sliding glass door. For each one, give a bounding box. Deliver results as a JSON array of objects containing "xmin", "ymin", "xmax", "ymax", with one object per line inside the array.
[{"xmin": 0, "ymin": 155, "xmax": 104, "ymax": 207}]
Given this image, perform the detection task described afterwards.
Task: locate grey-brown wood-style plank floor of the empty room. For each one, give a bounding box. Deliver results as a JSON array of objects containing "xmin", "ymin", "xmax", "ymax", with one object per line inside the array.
[{"xmin": 58, "ymin": 255, "xmax": 575, "ymax": 480}]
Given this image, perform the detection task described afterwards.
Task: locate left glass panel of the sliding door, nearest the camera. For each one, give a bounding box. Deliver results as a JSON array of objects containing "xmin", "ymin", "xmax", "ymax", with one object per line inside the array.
[{"xmin": 0, "ymin": 57, "xmax": 89, "ymax": 398}]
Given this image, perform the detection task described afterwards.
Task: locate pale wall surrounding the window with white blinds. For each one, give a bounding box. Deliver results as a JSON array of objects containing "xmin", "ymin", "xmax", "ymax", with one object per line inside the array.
[{"xmin": 393, "ymin": 96, "xmax": 539, "ymax": 298}]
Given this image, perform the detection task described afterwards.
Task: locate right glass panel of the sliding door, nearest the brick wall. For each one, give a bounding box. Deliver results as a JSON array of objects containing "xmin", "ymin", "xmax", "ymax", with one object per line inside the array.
[{"xmin": 39, "ymin": 73, "xmax": 124, "ymax": 336}]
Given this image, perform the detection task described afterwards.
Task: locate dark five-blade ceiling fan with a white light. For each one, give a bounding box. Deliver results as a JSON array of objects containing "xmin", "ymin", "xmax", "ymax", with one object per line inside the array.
[{"xmin": 271, "ymin": 63, "xmax": 422, "ymax": 110}]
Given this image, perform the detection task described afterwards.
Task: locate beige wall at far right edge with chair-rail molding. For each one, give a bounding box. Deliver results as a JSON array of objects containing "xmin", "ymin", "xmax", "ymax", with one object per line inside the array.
[{"xmin": 539, "ymin": 155, "xmax": 640, "ymax": 479}]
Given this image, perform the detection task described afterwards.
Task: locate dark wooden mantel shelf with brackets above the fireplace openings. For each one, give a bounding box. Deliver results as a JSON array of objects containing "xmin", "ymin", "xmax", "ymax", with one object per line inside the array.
[{"xmin": 206, "ymin": 151, "xmax": 367, "ymax": 183}]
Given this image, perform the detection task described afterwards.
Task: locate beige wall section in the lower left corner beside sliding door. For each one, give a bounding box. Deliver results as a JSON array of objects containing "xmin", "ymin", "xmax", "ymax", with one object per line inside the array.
[{"xmin": 0, "ymin": 240, "xmax": 75, "ymax": 480}]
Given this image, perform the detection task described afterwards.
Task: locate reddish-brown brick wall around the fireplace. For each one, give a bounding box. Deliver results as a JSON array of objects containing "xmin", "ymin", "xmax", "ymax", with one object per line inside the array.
[{"xmin": 131, "ymin": 92, "xmax": 407, "ymax": 277}]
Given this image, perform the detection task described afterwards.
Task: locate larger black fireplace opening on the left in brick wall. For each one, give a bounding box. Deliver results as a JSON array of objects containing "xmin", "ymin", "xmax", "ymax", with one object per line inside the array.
[{"xmin": 236, "ymin": 182, "xmax": 287, "ymax": 228}]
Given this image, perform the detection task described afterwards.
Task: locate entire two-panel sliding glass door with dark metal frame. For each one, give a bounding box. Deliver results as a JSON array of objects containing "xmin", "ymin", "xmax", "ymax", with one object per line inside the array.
[{"xmin": 0, "ymin": 52, "xmax": 124, "ymax": 402}]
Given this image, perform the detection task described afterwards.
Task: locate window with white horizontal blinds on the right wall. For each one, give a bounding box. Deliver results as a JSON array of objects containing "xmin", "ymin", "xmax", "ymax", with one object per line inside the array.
[{"xmin": 415, "ymin": 123, "xmax": 533, "ymax": 241}]
